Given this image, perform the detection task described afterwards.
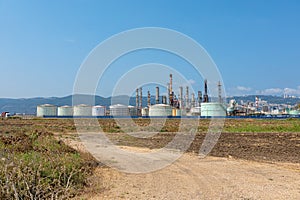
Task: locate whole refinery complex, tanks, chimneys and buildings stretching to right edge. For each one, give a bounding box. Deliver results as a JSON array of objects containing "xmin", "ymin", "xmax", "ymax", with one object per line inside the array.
[{"xmin": 33, "ymin": 74, "xmax": 300, "ymax": 118}]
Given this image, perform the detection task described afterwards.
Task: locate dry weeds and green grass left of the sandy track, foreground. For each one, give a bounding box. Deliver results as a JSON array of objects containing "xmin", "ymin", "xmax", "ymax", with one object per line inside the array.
[{"xmin": 0, "ymin": 123, "xmax": 96, "ymax": 199}]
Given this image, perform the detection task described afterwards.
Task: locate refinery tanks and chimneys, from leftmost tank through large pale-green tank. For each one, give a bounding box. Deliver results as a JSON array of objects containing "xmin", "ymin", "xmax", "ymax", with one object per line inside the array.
[{"xmin": 37, "ymin": 74, "xmax": 226, "ymax": 117}]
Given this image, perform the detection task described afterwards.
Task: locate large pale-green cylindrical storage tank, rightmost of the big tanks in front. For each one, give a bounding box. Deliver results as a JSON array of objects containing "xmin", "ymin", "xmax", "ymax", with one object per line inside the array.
[{"xmin": 201, "ymin": 102, "xmax": 226, "ymax": 117}]
